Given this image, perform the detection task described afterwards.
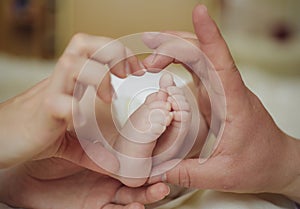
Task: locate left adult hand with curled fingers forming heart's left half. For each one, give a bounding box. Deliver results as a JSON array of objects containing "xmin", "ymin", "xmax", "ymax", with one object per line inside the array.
[{"xmin": 0, "ymin": 34, "xmax": 143, "ymax": 171}]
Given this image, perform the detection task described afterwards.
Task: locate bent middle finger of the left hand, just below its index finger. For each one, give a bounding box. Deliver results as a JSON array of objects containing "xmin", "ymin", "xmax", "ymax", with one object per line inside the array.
[{"xmin": 49, "ymin": 54, "xmax": 113, "ymax": 102}]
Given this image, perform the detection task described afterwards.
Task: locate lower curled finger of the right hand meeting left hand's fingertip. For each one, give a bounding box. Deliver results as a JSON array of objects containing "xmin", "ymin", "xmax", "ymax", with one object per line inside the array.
[{"xmin": 144, "ymin": 34, "xmax": 218, "ymax": 118}]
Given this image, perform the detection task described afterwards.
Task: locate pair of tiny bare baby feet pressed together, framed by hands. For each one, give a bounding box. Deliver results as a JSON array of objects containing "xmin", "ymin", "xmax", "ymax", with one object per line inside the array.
[{"xmin": 114, "ymin": 74, "xmax": 190, "ymax": 187}]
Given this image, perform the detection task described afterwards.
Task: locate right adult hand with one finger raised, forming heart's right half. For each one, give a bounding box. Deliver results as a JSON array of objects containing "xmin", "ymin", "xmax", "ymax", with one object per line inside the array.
[{"xmin": 144, "ymin": 5, "xmax": 300, "ymax": 201}]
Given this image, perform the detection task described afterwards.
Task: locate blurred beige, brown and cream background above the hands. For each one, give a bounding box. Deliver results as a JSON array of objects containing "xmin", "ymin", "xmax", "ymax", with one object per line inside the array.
[{"xmin": 0, "ymin": 0, "xmax": 300, "ymax": 138}]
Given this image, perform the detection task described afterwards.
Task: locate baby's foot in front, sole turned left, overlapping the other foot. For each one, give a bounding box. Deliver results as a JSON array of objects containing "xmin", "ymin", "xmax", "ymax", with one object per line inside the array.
[{"xmin": 114, "ymin": 74, "xmax": 178, "ymax": 187}]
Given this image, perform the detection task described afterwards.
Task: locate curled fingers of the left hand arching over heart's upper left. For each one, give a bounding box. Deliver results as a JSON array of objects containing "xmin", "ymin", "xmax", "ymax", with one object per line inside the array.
[{"xmin": 52, "ymin": 34, "xmax": 145, "ymax": 102}]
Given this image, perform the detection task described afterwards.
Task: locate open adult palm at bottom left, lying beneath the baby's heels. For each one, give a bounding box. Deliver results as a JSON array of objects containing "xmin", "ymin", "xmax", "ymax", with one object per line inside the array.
[{"xmin": 0, "ymin": 158, "xmax": 169, "ymax": 209}]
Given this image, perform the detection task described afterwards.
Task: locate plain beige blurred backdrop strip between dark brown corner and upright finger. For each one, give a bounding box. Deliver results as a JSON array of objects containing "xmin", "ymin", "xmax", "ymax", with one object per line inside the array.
[{"xmin": 56, "ymin": 0, "xmax": 216, "ymax": 54}]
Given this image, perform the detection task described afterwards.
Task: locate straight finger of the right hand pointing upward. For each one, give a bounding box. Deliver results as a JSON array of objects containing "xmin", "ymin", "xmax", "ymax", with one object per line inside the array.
[{"xmin": 193, "ymin": 5, "xmax": 244, "ymax": 98}]
